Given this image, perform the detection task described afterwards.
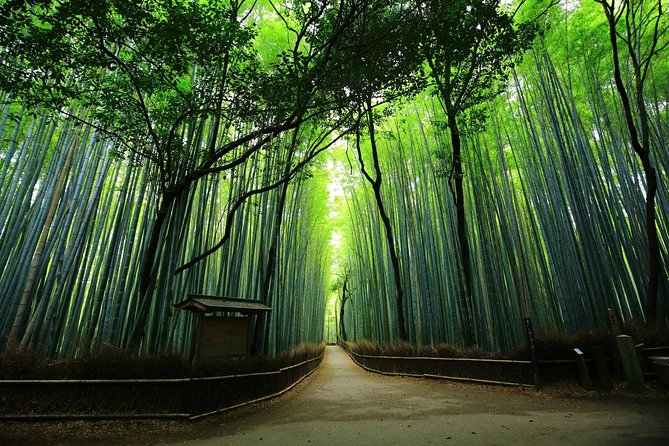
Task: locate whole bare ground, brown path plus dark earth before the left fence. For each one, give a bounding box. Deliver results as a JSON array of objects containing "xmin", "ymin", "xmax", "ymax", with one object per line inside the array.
[{"xmin": 0, "ymin": 347, "xmax": 669, "ymax": 446}]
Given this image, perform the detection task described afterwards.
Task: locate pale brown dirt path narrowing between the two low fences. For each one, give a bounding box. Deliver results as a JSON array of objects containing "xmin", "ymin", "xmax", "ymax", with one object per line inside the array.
[{"xmin": 159, "ymin": 347, "xmax": 669, "ymax": 446}]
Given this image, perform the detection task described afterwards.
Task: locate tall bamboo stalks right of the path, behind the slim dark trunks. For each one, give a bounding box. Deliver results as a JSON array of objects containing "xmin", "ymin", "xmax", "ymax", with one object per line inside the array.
[{"xmin": 344, "ymin": 2, "xmax": 669, "ymax": 351}]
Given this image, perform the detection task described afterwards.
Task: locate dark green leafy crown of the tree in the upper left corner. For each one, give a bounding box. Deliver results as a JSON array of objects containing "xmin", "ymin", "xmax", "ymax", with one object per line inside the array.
[{"xmin": 0, "ymin": 0, "xmax": 266, "ymax": 179}]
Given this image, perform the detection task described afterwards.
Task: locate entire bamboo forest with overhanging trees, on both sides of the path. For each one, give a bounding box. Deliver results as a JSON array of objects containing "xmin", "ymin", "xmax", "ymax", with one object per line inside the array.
[{"xmin": 0, "ymin": 0, "xmax": 669, "ymax": 358}]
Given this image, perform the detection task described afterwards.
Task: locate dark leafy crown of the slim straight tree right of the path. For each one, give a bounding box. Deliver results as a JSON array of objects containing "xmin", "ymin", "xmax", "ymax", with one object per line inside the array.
[{"xmin": 416, "ymin": 0, "xmax": 537, "ymax": 118}]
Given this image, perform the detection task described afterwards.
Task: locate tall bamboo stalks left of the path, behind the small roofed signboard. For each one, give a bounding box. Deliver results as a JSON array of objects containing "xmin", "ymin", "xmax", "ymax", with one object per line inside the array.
[{"xmin": 0, "ymin": 100, "xmax": 329, "ymax": 357}]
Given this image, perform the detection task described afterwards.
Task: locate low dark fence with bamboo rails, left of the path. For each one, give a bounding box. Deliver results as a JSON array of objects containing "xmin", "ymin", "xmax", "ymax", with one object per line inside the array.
[{"xmin": 0, "ymin": 353, "xmax": 323, "ymax": 420}]
